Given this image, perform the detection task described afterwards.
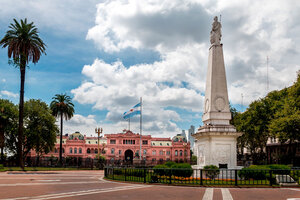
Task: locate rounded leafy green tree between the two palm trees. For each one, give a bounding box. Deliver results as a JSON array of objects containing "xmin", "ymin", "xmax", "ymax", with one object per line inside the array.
[{"xmin": 23, "ymin": 99, "xmax": 58, "ymax": 164}]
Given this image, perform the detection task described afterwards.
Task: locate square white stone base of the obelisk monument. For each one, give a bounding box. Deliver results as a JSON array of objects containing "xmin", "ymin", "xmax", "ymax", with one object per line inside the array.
[{"xmin": 193, "ymin": 125, "xmax": 242, "ymax": 169}]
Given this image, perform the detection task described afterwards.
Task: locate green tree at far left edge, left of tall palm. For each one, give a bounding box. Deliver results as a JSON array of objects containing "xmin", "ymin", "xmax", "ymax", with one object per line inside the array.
[{"xmin": 0, "ymin": 99, "xmax": 18, "ymax": 163}]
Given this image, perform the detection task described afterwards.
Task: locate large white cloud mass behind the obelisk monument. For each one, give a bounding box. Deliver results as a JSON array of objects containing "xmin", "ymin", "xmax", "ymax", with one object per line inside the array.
[{"xmin": 72, "ymin": 0, "xmax": 300, "ymax": 136}]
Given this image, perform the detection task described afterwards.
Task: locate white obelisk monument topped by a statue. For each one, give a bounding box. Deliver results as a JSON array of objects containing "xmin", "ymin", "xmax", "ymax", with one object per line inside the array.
[{"xmin": 193, "ymin": 17, "xmax": 242, "ymax": 168}]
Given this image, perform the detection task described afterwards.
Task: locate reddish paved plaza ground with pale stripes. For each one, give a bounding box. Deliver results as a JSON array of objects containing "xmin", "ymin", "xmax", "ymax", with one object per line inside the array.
[{"xmin": 0, "ymin": 171, "xmax": 300, "ymax": 200}]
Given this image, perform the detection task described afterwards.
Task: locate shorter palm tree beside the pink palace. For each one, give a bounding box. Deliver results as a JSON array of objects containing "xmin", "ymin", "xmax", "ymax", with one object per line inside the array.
[{"xmin": 50, "ymin": 94, "xmax": 74, "ymax": 164}]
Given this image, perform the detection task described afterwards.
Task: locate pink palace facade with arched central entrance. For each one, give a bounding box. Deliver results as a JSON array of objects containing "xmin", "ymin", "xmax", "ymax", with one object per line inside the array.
[{"xmin": 30, "ymin": 130, "xmax": 190, "ymax": 162}]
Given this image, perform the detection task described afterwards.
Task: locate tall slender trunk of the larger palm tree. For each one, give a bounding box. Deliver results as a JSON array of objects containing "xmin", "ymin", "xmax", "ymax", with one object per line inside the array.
[{"xmin": 18, "ymin": 59, "xmax": 26, "ymax": 169}]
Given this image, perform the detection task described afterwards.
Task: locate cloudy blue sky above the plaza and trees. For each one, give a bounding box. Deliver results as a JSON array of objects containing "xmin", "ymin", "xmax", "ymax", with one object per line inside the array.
[{"xmin": 0, "ymin": 0, "xmax": 300, "ymax": 137}]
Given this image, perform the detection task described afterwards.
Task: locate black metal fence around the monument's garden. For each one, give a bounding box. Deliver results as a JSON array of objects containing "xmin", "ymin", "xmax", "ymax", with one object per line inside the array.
[{"xmin": 104, "ymin": 167, "xmax": 300, "ymax": 186}]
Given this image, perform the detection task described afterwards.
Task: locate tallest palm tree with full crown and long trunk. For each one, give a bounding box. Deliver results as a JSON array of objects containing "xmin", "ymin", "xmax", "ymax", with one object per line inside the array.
[{"xmin": 0, "ymin": 18, "xmax": 46, "ymax": 168}]
